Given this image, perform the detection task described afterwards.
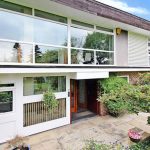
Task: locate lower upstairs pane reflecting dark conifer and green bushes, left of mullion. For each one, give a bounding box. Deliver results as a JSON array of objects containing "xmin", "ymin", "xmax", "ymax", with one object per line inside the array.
[{"xmin": 35, "ymin": 45, "xmax": 68, "ymax": 64}]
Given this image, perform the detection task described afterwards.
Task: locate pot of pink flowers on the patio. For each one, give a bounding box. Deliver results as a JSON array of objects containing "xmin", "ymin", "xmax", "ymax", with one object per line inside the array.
[{"xmin": 128, "ymin": 129, "xmax": 142, "ymax": 143}]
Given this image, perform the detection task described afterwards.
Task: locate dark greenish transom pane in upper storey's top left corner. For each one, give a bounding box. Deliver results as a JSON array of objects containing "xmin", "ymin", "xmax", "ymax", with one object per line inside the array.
[{"xmin": 0, "ymin": 0, "xmax": 32, "ymax": 15}]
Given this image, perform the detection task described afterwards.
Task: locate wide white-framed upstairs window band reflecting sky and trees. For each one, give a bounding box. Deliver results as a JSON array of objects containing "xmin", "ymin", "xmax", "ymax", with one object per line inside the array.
[{"xmin": 0, "ymin": 7, "xmax": 114, "ymax": 65}]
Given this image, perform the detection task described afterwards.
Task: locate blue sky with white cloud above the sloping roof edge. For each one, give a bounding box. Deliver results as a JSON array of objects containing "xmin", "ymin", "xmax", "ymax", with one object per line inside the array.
[{"xmin": 96, "ymin": 0, "xmax": 150, "ymax": 21}]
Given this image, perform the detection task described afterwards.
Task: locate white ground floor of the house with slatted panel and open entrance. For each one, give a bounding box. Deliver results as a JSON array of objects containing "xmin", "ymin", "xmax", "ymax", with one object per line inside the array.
[{"xmin": 0, "ymin": 72, "xmax": 146, "ymax": 143}]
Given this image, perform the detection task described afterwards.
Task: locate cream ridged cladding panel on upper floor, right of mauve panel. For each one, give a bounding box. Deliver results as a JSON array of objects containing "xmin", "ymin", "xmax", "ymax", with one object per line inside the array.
[{"xmin": 128, "ymin": 32, "xmax": 149, "ymax": 66}]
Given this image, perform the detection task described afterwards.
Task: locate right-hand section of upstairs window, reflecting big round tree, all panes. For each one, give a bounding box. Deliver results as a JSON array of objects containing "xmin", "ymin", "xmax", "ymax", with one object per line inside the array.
[{"xmin": 71, "ymin": 22, "xmax": 114, "ymax": 65}]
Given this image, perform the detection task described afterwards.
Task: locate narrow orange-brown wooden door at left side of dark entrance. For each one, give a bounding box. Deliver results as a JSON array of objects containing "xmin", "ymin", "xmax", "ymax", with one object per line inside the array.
[{"xmin": 70, "ymin": 80, "xmax": 78, "ymax": 113}]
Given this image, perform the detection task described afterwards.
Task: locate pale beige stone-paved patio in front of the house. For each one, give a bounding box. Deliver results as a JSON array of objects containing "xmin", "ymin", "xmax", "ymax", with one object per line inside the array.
[{"xmin": 0, "ymin": 113, "xmax": 150, "ymax": 150}]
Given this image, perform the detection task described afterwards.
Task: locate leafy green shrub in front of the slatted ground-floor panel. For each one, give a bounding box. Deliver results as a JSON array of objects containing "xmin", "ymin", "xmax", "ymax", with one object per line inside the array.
[{"xmin": 43, "ymin": 89, "xmax": 58, "ymax": 111}]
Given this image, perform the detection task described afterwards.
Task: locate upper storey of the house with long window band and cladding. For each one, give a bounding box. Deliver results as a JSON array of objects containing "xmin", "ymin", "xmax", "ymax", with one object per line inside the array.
[{"xmin": 0, "ymin": 1, "xmax": 149, "ymax": 66}]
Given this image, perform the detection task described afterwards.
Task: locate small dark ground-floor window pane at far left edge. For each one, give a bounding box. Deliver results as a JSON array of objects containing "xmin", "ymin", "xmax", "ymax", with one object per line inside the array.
[{"xmin": 0, "ymin": 91, "xmax": 13, "ymax": 113}]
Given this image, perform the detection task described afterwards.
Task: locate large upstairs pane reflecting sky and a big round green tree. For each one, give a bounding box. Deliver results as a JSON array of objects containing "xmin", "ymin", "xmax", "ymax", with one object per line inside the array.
[{"xmin": 71, "ymin": 27, "xmax": 114, "ymax": 51}]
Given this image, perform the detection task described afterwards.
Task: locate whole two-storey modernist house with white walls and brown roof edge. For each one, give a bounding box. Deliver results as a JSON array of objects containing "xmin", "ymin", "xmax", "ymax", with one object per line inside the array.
[{"xmin": 0, "ymin": 0, "xmax": 150, "ymax": 142}]
